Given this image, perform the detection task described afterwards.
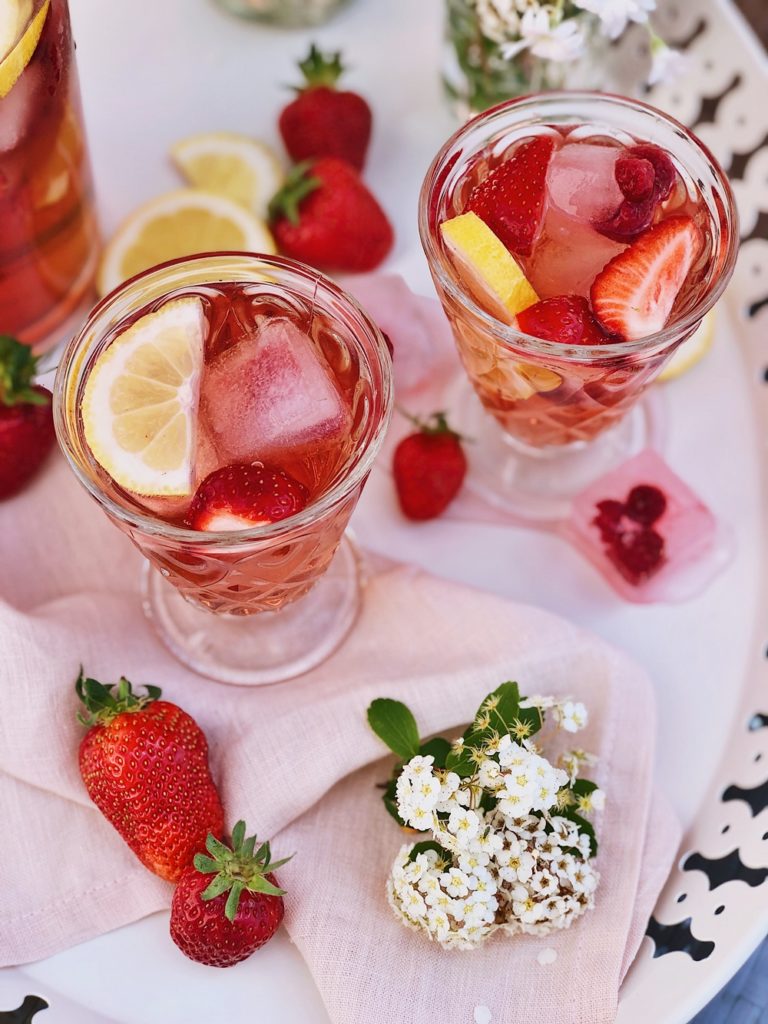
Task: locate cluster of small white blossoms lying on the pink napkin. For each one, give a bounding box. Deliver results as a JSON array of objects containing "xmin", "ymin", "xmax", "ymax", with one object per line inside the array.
[{"xmin": 387, "ymin": 698, "xmax": 604, "ymax": 949}]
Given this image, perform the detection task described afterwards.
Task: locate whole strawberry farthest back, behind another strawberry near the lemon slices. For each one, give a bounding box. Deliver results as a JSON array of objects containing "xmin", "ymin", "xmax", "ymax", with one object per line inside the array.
[{"xmin": 280, "ymin": 44, "xmax": 372, "ymax": 171}]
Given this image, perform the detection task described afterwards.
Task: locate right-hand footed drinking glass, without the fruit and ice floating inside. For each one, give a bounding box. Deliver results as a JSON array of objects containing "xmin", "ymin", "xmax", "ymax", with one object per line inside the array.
[{"xmin": 419, "ymin": 91, "xmax": 738, "ymax": 520}]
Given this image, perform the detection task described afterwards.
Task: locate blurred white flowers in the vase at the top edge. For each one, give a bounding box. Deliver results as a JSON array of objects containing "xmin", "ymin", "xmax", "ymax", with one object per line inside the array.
[{"xmin": 470, "ymin": 0, "xmax": 681, "ymax": 84}]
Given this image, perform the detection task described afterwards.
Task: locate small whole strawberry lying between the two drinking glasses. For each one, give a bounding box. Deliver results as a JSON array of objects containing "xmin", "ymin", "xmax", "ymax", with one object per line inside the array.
[{"xmin": 392, "ymin": 413, "xmax": 467, "ymax": 519}]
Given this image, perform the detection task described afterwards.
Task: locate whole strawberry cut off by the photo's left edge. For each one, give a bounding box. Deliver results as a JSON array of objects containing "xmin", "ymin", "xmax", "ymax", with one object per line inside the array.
[{"xmin": 0, "ymin": 335, "xmax": 55, "ymax": 499}]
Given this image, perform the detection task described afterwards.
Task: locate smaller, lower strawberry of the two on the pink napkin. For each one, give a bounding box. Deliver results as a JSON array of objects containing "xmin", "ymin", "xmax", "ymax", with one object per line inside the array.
[{"xmin": 171, "ymin": 821, "xmax": 291, "ymax": 967}]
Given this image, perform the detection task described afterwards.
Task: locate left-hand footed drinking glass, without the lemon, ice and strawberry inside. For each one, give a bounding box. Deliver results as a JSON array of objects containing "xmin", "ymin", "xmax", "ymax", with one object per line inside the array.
[{"xmin": 53, "ymin": 253, "xmax": 392, "ymax": 684}]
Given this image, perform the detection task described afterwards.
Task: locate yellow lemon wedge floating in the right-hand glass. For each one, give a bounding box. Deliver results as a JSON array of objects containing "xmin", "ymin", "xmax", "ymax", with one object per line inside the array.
[{"xmin": 440, "ymin": 213, "xmax": 539, "ymax": 324}]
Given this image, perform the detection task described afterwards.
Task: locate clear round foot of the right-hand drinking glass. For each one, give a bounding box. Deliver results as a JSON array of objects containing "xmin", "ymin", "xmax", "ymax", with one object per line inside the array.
[{"xmin": 446, "ymin": 376, "xmax": 664, "ymax": 522}]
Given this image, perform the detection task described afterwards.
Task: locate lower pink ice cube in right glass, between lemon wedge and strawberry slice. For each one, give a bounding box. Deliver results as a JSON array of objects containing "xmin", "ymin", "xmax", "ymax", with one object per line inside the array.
[{"xmin": 525, "ymin": 206, "xmax": 627, "ymax": 299}]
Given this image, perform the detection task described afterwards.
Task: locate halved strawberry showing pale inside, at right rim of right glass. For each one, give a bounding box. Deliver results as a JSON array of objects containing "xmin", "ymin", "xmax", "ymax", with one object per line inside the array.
[{"xmin": 590, "ymin": 217, "xmax": 702, "ymax": 341}]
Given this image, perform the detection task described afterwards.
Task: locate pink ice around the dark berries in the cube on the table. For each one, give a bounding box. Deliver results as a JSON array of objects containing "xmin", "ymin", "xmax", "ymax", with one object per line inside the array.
[{"xmin": 565, "ymin": 449, "xmax": 729, "ymax": 603}]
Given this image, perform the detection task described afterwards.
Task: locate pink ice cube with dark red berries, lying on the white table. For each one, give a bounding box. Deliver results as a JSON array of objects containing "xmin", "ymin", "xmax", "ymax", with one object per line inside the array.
[{"xmin": 566, "ymin": 450, "xmax": 728, "ymax": 603}]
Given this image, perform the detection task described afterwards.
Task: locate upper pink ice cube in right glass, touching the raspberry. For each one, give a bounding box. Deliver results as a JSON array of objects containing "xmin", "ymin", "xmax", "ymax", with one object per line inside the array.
[{"xmin": 547, "ymin": 142, "xmax": 624, "ymax": 224}]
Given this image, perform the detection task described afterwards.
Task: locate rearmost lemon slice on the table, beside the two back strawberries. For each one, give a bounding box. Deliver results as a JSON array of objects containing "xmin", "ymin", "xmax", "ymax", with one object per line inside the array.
[{"xmin": 171, "ymin": 131, "xmax": 285, "ymax": 220}]
